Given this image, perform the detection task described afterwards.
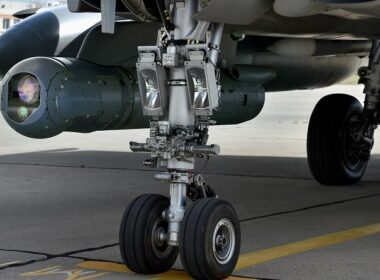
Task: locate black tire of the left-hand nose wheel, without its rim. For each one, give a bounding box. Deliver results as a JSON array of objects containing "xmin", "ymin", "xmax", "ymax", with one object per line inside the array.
[{"xmin": 119, "ymin": 194, "xmax": 178, "ymax": 274}]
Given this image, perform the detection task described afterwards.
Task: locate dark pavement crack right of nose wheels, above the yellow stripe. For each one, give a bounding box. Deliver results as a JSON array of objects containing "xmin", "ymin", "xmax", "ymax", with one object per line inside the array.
[{"xmin": 239, "ymin": 193, "xmax": 380, "ymax": 223}]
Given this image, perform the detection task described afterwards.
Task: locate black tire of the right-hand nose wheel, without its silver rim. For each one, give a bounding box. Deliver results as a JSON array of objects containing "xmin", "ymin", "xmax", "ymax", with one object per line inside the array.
[{"xmin": 180, "ymin": 198, "xmax": 241, "ymax": 279}]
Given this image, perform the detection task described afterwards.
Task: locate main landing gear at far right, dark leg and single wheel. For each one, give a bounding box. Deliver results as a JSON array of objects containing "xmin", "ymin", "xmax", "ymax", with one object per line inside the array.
[{"xmin": 307, "ymin": 41, "xmax": 380, "ymax": 185}]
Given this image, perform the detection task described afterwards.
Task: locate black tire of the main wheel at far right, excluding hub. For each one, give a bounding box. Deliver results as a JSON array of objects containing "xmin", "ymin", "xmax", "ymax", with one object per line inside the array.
[{"xmin": 307, "ymin": 94, "xmax": 368, "ymax": 185}]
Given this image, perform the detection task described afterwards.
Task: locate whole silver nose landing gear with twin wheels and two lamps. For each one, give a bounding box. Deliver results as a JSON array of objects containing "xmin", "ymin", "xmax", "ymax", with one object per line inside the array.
[{"xmin": 120, "ymin": 0, "xmax": 240, "ymax": 279}]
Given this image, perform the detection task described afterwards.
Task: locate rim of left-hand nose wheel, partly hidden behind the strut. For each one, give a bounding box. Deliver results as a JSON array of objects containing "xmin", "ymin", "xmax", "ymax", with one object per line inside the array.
[{"xmin": 151, "ymin": 217, "xmax": 173, "ymax": 259}]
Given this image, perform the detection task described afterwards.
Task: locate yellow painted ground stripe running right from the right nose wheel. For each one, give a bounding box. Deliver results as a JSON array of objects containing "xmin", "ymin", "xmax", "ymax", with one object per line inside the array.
[{"xmin": 235, "ymin": 223, "xmax": 380, "ymax": 270}]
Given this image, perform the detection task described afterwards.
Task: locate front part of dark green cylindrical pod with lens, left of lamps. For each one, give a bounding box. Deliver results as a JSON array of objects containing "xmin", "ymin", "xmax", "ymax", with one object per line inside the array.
[{"xmin": 1, "ymin": 57, "xmax": 141, "ymax": 138}]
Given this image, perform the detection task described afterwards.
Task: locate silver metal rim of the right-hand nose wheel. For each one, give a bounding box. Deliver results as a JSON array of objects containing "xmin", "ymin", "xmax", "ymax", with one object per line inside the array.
[{"xmin": 212, "ymin": 218, "xmax": 236, "ymax": 265}]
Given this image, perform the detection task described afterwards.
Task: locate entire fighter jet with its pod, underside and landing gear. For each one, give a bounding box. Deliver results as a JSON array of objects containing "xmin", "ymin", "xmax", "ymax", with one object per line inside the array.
[{"xmin": 0, "ymin": 0, "xmax": 380, "ymax": 279}]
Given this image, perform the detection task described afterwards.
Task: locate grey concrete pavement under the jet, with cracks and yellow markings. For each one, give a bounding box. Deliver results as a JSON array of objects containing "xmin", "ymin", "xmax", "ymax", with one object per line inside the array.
[{"xmin": 0, "ymin": 86, "xmax": 380, "ymax": 280}]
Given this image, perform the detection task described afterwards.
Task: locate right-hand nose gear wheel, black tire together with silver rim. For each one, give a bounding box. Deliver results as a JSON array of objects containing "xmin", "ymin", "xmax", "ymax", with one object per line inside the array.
[{"xmin": 180, "ymin": 198, "xmax": 240, "ymax": 279}]
